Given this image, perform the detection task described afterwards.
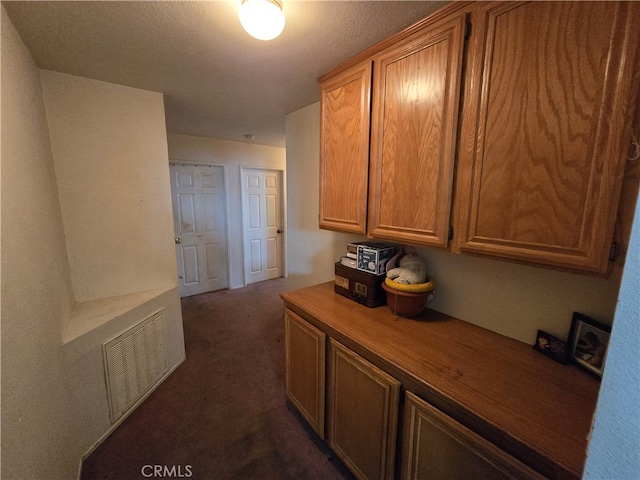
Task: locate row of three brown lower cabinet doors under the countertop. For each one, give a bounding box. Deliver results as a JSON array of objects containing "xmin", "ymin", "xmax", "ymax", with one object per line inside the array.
[{"xmin": 285, "ymin": 309, "xmax": 544, "ymax": 480}]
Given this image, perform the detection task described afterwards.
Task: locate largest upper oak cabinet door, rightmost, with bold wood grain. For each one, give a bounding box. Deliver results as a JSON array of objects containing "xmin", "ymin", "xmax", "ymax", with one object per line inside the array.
[{"xmin": 456, "ymin": 2, "xmax": 640, "ymax": 272}]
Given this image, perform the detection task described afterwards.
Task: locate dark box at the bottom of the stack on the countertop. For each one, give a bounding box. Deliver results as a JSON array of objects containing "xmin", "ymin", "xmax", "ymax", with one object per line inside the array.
[{"xmin": 334, "ymin": 262, "xmax": 387, "ymax": 307}]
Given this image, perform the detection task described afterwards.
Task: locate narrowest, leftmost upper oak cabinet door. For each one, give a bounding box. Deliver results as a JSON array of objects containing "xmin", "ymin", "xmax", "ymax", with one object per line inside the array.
[{"xmin": 319, "ymin": 60, "xmax": 371, "ymax": 234}]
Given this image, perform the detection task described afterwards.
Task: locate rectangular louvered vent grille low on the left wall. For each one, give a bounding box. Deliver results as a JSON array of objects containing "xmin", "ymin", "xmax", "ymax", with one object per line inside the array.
[{"xmin": 102, "ymin": 309, "xmax": 168, "ymax": 423}]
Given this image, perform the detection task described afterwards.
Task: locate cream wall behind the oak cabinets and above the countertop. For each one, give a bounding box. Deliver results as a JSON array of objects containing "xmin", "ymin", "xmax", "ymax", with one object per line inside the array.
[{"xmin": 286, "ymin": 104, "xmax": 619, "ymax": 345}]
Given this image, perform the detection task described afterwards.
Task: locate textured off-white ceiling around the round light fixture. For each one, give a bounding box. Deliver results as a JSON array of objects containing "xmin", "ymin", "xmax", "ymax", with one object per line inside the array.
[{"xmin": 2, "ymin": 0, "xmax": 446, "ymax": 146}]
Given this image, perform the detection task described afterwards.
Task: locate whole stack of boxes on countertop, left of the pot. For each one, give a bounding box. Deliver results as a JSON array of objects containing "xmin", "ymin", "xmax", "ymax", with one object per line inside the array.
[{"xmin": 334, "ymin": 242, "xmax": 396, "ymax": 307}]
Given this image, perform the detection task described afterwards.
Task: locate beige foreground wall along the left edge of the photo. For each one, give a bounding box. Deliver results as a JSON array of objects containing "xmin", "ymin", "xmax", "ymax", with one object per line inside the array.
[{"xmin": 0, "ymin": 7, "xmax": 79, "ymax": 479}]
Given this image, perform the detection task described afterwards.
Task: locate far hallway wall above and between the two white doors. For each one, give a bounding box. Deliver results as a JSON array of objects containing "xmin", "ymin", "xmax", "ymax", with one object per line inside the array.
[{"xmin": 167, "ymin": 133, "xmax": 286, "ymax": 288}]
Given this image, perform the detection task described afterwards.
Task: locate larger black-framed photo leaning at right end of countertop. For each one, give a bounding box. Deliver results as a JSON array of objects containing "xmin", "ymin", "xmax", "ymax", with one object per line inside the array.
[{"xmin": 569, "ymin": 312, "xmax": 611, "ymax": 378}]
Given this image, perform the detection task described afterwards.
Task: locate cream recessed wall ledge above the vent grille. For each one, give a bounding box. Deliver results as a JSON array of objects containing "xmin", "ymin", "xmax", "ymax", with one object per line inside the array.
[{"xmin": 62, "ymin": 287, "xmax": 175, "ymax": 345}]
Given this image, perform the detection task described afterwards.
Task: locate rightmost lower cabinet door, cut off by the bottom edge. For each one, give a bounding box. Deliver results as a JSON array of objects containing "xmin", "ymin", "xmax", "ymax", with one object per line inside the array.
[{"xmin": 402, "ymin": 392, "xmax": 544, "ymax": 480}]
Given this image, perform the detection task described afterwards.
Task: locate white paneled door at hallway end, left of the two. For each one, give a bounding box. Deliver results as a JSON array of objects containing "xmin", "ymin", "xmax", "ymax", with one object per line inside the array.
[{"xmin": 170, "ymin": 164, "xmax": 229, "ymax": 297}]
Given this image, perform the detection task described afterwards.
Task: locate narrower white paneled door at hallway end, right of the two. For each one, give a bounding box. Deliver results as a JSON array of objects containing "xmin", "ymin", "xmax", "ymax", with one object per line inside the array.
[{"xmin": 242, "ymin": 168, "xmax": 282, "ymax": 284}]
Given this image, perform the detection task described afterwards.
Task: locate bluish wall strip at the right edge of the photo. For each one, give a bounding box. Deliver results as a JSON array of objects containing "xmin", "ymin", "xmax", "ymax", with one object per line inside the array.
[{"xmin": 584, "ymin": 198, "xmax": 640, "ymax": 480}]
